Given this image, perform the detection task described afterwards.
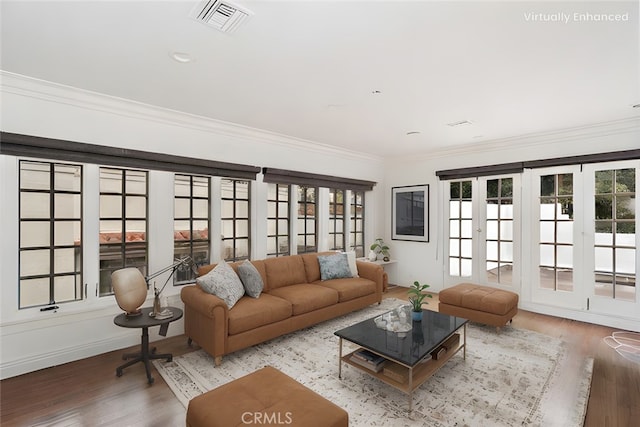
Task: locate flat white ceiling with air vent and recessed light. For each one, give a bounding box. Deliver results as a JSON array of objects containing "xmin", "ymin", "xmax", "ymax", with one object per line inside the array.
[{"xmin": 0, "ymin": 0, "xmax": 640, "ymax": 156}]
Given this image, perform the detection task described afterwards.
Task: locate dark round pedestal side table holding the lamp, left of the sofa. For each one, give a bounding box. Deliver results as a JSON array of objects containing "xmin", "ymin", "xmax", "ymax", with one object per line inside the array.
[{"xmin": 113, "ymin": 307, "xmax": 182, "ymax": 384}]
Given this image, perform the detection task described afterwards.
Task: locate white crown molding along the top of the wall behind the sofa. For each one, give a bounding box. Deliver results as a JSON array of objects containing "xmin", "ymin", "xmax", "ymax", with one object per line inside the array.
[{"xmin": 0, "ymin": 70, "xmax": 383, "ymax": 162}]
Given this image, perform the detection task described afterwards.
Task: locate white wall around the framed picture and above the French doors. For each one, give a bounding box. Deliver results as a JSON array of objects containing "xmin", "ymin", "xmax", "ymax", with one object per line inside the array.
[{"xmin": 384, "ymin": 118, "xmax": 640, "ymax": 330}]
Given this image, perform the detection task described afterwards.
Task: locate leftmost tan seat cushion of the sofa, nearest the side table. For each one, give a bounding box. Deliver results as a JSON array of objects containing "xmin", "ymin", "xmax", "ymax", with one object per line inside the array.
[{"xmin": 229, "ymin": 293, "xmax": 293, "ymax": 335}]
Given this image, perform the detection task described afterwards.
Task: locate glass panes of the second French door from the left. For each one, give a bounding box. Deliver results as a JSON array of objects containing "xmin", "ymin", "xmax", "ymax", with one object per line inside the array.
[{"xmin": 486, "ymin": 178, "xmax": 513, "ymax": 284}]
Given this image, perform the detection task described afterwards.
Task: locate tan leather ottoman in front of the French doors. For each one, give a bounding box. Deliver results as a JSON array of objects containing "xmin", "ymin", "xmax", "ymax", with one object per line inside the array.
[{"xmin": 438, "ymin": 283, "xmax": 518, "ymax": 328}]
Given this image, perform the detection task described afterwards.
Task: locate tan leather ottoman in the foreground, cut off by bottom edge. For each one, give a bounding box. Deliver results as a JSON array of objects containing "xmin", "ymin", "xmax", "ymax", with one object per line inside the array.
[{"xmin": 187, "ymin": 366, "xmax": 349, "ymax": 427}]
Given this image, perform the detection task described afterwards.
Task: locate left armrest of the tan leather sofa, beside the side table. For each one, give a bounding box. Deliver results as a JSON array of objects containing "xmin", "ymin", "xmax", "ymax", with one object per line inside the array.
[{"xmin": 180, "ymin": 285, "xmax": 229, "ymax": 364}]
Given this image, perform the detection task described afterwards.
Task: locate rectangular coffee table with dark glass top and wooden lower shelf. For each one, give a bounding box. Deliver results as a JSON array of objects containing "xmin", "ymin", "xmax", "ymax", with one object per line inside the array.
[{"xmin": 335, "ymin": 310, "xmax": 467, "ymax": 411}]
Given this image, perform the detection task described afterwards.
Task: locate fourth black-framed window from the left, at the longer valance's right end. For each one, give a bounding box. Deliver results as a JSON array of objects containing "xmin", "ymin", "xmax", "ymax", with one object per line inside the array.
[{"xmin": 221, "ymin": 179, "xmax": 251, "ymax": 261}]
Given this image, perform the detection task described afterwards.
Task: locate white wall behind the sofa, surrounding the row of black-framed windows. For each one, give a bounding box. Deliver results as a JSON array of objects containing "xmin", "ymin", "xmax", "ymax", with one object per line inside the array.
[{"xmin": 0, "ymin": 72, "xmax": 384, "ymax": 378}]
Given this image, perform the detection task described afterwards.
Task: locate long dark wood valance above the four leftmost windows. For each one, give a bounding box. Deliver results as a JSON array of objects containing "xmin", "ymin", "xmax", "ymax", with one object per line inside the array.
[{"xmin": 0, "ymin": 132, "xmax": 260, "ymax": 180}]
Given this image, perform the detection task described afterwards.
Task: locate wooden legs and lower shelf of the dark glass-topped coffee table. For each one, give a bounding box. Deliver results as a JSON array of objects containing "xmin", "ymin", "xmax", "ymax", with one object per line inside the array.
[{"xmin": 338, "ymin": 324, "xmax": 467, "ymax": 411}]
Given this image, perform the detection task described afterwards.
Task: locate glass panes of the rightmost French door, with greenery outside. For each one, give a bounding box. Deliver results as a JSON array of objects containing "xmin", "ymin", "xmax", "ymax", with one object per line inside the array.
[{"xmin": 594, "ymin": 169, "xmax": 636, "ymax": 301}]
